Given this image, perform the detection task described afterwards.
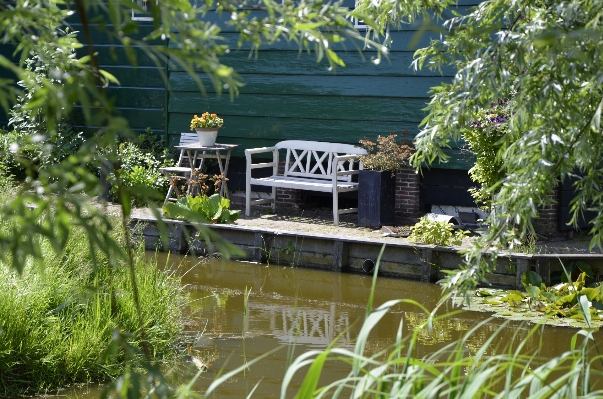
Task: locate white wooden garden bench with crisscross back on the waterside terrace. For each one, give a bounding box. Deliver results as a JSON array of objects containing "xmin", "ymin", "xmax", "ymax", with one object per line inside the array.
[{"xmin": 245, "ymin": 140, "xmax": 366, "ymax": 226}]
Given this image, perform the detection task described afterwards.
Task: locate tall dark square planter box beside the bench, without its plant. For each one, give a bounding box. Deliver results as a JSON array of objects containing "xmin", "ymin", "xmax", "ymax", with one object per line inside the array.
[{"xmin": 358, "ymin": 170, "xmax": 396, "ymax": 228}]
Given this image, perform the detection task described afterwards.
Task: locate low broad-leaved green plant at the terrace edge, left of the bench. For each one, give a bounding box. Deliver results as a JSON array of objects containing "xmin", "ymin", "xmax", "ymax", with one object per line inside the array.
[{"xmin": 163, "ymin": 194, "xmax": 241, "ymax": 223}]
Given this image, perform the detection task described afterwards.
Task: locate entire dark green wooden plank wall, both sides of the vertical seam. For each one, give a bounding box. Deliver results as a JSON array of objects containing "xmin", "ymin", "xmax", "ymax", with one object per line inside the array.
[{"xmin": 0, "ymin": 0, "xmax": 479, "ymax": 170}]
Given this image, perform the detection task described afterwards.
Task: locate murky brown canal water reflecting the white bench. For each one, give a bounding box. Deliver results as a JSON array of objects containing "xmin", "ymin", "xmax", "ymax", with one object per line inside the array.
[{"xmin": 54, "ymin": 254, "xmax": 596, "ymax": 399}]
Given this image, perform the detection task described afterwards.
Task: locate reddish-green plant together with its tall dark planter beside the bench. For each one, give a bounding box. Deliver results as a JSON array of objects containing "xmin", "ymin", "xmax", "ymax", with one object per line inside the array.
[{"xmin": 358, "ymin": 133, "xmax": 414, "ymax": 228}]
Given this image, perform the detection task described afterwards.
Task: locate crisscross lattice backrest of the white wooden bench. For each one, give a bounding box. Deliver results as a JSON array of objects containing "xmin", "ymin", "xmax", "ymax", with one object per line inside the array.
[{"xmin": 275, "ymin": 140, "xmax": 366, "ymax": 181}]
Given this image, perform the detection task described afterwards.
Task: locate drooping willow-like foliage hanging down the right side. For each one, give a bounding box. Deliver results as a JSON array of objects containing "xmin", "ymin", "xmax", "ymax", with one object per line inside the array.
[{"xmin": 368, "ymin": 0, "xmax": 603, "ymax": 292}]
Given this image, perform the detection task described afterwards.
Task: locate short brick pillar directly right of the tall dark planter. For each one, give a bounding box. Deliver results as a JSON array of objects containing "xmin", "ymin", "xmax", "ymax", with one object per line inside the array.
[{"xmin": 395, "ymin": 168, "xmax": 419, "ymax": 225}]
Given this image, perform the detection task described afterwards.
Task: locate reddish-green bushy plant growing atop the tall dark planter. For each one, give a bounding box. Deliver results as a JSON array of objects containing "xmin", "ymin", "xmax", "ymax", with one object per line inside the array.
[{"xmin": 359, "ymin": 133, "xmax": 415, "ymax": 176}]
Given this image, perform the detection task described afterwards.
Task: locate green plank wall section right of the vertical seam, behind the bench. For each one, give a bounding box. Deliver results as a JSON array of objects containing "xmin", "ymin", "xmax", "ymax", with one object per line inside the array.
[{"xmin": 167, "ymin": 0, "xmax": 478, "ymax": 170}]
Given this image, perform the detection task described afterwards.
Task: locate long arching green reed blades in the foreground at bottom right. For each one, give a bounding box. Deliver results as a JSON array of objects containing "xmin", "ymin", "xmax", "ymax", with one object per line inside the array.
[{"xmin": 281, "ymin": 247, "xmax": 603, "ymax": 399}]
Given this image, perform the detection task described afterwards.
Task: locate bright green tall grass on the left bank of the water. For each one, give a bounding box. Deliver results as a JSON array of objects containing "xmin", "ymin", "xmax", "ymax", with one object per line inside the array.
[{"xmin": 0, "ymin": 185, "xmax": 184, "ymax": 396}]
